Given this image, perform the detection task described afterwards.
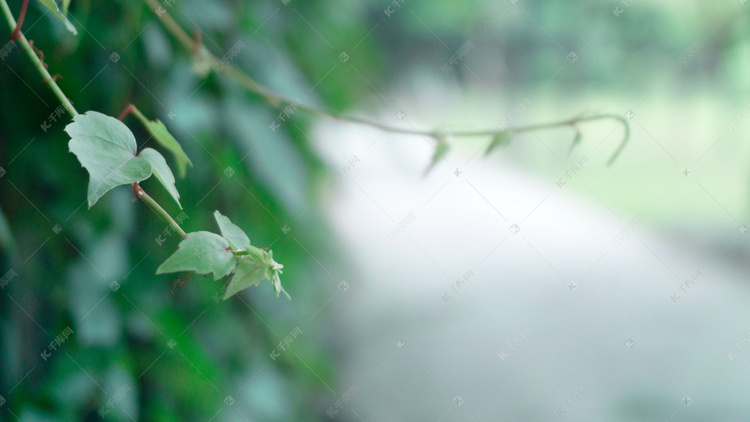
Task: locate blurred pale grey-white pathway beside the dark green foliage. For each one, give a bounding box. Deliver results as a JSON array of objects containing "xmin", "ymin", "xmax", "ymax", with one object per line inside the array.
[{"xmin": 324, "ymin": 125, "xmax": 750, "ymax": 422}]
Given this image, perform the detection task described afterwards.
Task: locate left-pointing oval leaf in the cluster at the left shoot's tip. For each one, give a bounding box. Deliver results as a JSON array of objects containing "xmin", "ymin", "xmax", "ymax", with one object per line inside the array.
[{"xmin": 156, "ymin": 231, "xmax": 237, "ymax": 280}]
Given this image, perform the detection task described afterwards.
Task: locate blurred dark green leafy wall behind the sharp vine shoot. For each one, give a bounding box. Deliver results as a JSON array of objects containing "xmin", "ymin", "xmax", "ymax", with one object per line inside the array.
[{"xmin": 0, "ymin": 0, "xmax": 384, "ymax": 421}]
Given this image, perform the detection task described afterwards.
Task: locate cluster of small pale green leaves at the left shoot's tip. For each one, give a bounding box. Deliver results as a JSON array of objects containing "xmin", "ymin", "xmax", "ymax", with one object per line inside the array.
[{"xmin": 156, "ymin": 211, "xmax": 289, "ymax": 300}]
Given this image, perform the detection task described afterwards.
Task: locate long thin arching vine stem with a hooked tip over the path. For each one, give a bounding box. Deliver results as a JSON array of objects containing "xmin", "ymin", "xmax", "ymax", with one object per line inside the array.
[{"xmin": 143, "ymin": 0, "xmax": 630, "ymax": 164}]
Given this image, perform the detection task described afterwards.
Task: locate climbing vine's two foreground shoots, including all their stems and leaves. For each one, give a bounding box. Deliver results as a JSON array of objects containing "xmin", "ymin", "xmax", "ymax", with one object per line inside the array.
[{"xmin": 0, "ymin": 0, "xmax": 629, "ymax": 299}]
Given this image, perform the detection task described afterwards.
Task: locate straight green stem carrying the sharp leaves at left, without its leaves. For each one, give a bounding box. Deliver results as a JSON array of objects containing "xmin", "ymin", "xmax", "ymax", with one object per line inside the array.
[{"xmin": 0, "ymin": 0, "xmax": 187, "ymax": 239}]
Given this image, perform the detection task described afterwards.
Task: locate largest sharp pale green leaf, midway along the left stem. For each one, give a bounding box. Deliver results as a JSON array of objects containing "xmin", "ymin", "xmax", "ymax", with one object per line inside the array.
[{"xmin": 65, "ymin": 111, "xmax": 152, "ymax": 208}]
